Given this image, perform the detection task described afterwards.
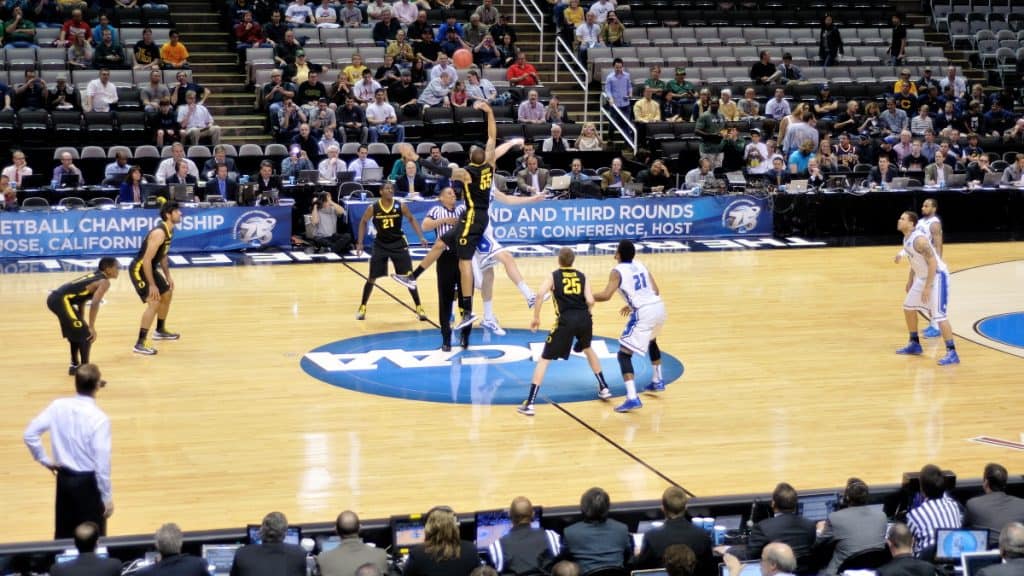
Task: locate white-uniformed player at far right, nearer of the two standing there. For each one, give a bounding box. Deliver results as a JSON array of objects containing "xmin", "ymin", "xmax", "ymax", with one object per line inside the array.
[{"xmin": 896, "ymin": 211, "xmax": 959, "ymax": 366}]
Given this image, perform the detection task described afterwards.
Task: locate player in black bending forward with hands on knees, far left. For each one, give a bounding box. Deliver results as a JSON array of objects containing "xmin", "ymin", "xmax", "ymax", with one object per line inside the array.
[{"xmin": 46, "ymin": 256, "xmax": 120, "ymax": 375}]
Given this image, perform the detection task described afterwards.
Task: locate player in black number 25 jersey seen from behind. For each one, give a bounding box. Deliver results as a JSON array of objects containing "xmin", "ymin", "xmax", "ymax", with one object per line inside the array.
[{"xmin": 517, "ymin": 247, "xmax": 611, "ymax": 416}]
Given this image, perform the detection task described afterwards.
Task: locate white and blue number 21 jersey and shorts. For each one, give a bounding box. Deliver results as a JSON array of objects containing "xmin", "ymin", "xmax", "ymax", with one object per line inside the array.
[{"xmin": 614, "ymin": 261, "xmax": 667, "ymax": 356}]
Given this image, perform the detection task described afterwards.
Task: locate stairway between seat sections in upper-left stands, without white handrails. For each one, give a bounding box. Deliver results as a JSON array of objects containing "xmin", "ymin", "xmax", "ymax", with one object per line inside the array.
[{"xmin": 170, "ymin": 0, "xmax": 271, "ymax": 146}]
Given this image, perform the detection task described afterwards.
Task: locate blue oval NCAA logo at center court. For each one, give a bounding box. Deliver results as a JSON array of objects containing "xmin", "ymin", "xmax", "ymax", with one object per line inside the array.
[{"xmin": 301, "ymin": 329, "xmax": 683, "ymax": 405}]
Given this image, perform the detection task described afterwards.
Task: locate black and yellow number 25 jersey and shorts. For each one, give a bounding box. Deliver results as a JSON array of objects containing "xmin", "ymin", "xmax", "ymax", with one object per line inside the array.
[{"xmin": 541, "ymin": 268, "xmax": 594, "ymax": 360}]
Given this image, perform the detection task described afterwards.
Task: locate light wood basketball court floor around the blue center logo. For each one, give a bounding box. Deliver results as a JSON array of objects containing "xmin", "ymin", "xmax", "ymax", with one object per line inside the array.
[{"xmin": 0, "ymin": 238, "xmax": 1024, "ymax": 542}]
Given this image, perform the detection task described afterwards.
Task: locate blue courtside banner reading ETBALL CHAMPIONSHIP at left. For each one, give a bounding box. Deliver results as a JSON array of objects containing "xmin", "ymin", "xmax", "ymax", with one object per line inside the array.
[{"xmin": 0, "ymin": 206, "xmax": 292, "ymax": 258}]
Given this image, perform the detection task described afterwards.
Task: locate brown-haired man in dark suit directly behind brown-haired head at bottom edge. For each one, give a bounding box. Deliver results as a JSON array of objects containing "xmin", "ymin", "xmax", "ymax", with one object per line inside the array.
[{"xmin": 636, "ymin": 486, "xmax": 715, "ymax": 576}]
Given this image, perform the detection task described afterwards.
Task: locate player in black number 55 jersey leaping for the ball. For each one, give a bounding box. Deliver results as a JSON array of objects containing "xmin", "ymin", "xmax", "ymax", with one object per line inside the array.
[{"xmin": 391, "ymin": 100, "xmax": 545, "ymax": 338}]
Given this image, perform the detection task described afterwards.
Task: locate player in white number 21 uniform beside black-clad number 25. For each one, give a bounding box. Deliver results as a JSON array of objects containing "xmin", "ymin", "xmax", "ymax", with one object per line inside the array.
[{"xmin": 594, "ymin": 240, "xmax": 666, "ymax": 412}]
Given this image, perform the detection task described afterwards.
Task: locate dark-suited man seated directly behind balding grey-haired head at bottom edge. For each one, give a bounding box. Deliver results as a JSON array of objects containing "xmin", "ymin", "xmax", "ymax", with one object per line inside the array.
[{"xmin": 723, "ymin": 482, "xmax": 817, "ymax": 573}]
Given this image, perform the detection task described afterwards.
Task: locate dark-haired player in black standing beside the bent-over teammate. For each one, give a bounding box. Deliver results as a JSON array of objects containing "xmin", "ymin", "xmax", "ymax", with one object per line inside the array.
[{"xmin": 128, "ymin": 200, "xmax": 181, "ymax": 356}]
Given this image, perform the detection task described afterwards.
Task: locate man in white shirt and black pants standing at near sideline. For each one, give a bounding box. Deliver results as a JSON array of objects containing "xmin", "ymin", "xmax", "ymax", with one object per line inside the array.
[{"xmin": 24, "ymin": 364, "xmax": 114, "ymax": 538}]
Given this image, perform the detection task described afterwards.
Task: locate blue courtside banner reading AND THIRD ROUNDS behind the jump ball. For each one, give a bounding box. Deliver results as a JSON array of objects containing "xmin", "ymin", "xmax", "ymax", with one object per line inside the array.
[{"xmin": 349, "ymin": 195, "xmax": 772, "ymax": 244}]
